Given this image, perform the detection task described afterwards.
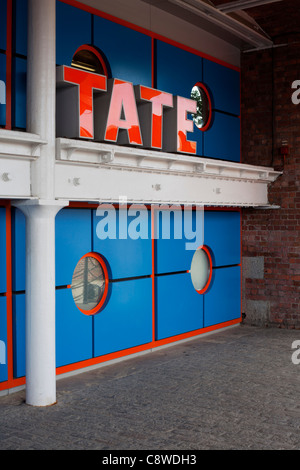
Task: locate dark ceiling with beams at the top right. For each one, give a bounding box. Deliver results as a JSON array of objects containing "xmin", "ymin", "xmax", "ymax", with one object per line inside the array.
[{"xmin": 139, "ymin": 0, "xmax": 300, "ymax": 51}]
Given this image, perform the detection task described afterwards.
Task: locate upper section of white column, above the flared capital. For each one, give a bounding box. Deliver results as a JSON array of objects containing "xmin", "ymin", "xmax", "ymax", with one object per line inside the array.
[{"xmin": 27, "ymin": 0, "xmax": 56, "ymax": 200}]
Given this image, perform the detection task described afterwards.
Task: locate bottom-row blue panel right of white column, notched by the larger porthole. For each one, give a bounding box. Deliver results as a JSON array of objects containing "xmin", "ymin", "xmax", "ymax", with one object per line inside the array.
[{"xmin": 56, "ymin": 289, "xmax": 93, "ymax": 367}]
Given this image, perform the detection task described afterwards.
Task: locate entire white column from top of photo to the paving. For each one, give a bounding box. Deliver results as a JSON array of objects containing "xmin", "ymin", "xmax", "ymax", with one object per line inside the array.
[{"xmin": 17, "ymin": 0, "xmax": 66, "ymax": 406}]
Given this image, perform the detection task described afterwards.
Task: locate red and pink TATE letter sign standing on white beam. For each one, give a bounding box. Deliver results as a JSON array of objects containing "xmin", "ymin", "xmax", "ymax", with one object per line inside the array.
[{"xmin": 56, "ymin": 66, "xmax": 211, "ymax": 154}]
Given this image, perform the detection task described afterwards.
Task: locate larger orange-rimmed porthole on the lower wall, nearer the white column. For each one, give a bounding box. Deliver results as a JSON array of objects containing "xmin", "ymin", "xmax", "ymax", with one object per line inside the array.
[{"xmin": 71, "ymin": 253, "xmax": 108, "ymax": 315}]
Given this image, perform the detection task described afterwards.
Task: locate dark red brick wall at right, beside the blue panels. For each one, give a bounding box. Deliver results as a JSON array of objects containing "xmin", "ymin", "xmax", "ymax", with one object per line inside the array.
[{"xmin": 241, "ymin": 34, "xmax": 300, "ymax": 328}]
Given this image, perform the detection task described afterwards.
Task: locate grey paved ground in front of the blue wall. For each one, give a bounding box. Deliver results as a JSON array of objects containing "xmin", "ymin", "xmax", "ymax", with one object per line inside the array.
[{"xmin": 0, "ymin": 325, "xmax": 300, "ymax": 453}]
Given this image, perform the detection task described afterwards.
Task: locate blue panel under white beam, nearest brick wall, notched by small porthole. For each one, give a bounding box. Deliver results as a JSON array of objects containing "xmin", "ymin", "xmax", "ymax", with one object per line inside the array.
[{"xmin": 204, "ymin": 211, "xmax": 241, "ymax": 267}]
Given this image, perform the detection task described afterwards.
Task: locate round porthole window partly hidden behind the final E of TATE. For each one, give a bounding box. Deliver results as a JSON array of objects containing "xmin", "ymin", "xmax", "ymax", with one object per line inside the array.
[{"xmin": 191, "ymin": 82, "xmax": 212, "ymax": 131}]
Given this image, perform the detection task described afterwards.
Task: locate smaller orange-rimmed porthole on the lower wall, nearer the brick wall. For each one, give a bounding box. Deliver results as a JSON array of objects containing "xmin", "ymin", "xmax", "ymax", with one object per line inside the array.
[{"xmin": 190, "ymin": 246, "xmax": 212, "ymax": 294}]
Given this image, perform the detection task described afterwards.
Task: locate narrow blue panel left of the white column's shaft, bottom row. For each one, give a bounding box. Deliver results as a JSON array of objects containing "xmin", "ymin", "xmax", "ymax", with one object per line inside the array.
[{"xmin": 12, "ymin": 294, "xmax": 26, "ymax": 378}]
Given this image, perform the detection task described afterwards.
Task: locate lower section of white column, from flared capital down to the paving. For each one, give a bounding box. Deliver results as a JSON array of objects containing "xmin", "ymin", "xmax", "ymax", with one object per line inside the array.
[{"xmin": 17, "ymin": 200, "xmax": 64, "ymax": 406}]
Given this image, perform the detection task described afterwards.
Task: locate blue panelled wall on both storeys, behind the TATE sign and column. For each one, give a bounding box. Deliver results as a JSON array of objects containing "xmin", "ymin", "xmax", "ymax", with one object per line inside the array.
[{"xmin": 0, "ymin": 0, "xmax": 241, "ymax": 382}]
